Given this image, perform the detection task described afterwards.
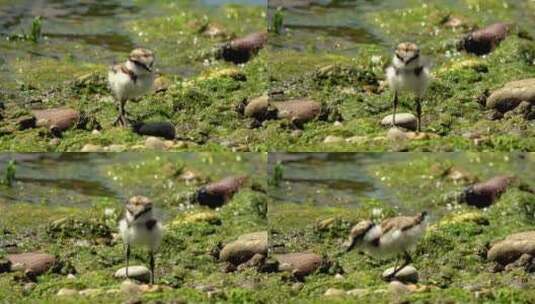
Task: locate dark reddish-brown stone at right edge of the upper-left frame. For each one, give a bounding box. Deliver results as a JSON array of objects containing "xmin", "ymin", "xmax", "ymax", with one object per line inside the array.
[{"xmin": 217, "ymin": 32, "xmax": 267, "ymax": 64}]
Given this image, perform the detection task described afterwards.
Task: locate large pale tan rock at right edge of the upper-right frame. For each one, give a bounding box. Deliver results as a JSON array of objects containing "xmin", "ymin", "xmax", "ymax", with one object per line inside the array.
[{"xmin": 487, "ymin": 78, "xmax": 535, "ymax": 113}]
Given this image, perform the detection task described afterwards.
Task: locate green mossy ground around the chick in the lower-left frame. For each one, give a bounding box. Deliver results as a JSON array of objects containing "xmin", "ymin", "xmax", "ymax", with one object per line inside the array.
[{"xmin": 0, "ymin": 154, "xmax": 270, "ymax": 303}]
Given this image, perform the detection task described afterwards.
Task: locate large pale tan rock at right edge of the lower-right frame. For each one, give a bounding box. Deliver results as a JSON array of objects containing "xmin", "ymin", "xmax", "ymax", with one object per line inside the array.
[{"xmin": 487, "ymin": 231, "xmax": 535, "ymax": 265}]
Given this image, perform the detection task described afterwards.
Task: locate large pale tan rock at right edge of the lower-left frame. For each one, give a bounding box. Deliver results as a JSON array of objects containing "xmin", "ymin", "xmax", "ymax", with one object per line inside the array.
[{"xmin": 219, "ymin": 231, "xmax": 268, "ymax": 265}]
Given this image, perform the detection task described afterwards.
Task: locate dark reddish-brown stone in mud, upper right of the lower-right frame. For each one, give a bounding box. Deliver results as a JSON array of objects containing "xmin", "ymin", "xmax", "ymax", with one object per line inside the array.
[{"xmin": 461, "ymin": 175, "xmax": 513, "ymax": 208}]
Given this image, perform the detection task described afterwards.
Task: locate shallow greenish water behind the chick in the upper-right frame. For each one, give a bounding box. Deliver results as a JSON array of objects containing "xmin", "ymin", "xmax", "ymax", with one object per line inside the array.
[{"xmin": 268, "ymin": 0, "xmax": 535, "ymax": 54}]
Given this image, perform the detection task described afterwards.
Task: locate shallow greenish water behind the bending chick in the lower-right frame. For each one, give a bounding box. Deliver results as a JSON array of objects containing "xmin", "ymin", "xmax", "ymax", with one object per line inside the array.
[{"xmin": 268, "ymin": 153, "xmax": 535, "ymax": 214}]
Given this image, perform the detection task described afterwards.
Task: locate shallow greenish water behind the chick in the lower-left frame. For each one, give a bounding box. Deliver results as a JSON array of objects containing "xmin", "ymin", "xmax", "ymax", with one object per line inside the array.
[{"xmin": 0, "ymin": 152, "xmax": 265, "ymax": 206}]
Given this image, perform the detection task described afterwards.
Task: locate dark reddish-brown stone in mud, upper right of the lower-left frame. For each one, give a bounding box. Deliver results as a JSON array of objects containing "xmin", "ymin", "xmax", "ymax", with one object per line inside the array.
[{"xmin": 195, "ymin": 176, "xmax": 247, "ymax": 208}]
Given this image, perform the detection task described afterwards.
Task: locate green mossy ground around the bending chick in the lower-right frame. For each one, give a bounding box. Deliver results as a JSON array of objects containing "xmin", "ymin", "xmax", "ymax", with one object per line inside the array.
[{"xmin": 268, "ymin": 153, "xmax": 535, "ymax": 303}]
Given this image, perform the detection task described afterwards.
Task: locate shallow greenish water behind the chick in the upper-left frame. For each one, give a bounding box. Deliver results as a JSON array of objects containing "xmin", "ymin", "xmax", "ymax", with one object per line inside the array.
[{"xmin": 0, "ymin": 0, "xmax": 266, "ymax": 88}]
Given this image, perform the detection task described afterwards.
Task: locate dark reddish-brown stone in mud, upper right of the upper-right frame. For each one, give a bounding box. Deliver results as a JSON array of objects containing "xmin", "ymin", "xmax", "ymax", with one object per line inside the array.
[{"xmin": 459, "ymin": 22, "xmax": 509, "ymax": 55}]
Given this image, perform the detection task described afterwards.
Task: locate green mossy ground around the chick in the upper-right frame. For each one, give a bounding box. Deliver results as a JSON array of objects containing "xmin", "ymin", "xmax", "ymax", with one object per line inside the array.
[{"xmin": 268, "ymin": 1, "xmax": 535, "ymax": 151}]
